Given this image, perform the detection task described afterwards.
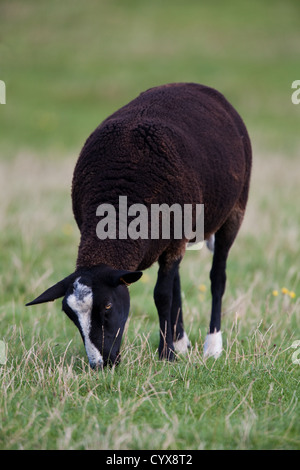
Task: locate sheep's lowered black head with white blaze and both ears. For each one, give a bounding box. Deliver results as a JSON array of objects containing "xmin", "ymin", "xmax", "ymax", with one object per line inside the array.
[{"xmin": 26, "ymin": 265, "xmax": 142, "ymax": 368}]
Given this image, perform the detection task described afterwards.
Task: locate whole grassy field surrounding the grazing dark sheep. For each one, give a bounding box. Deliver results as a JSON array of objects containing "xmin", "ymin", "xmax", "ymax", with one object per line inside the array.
[{"xmin": 0, "ymin": 0, "xmax": 300, "ymax": 450}]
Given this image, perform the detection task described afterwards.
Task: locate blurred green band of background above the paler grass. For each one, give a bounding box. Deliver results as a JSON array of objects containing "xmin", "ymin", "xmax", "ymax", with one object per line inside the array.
[{"xmin": 0, "ymin": 0, "xmax": 300, "ymax": 158}]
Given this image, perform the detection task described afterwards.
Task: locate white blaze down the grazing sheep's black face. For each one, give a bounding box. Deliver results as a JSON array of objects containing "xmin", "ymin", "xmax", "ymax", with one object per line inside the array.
[{"xmin": 67, "ymin": 277, "xmax": 103, "ymax": 366}]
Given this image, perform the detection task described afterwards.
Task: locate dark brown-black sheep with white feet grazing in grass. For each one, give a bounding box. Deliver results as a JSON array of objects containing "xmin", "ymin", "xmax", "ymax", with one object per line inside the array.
[{"xmin": 27, "ymin": 83, "xmax": 251, "ymax": 367}]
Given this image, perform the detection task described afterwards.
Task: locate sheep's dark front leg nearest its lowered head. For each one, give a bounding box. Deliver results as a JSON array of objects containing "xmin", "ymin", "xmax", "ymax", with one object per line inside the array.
[{"xmin": 154, "ymin": 256, "xmax": 180, "ymax": 361}]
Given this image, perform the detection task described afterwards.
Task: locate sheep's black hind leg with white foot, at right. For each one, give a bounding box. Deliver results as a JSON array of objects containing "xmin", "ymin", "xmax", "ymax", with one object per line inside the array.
[{"xmin": 204, "ymin": 209, "xmax": 244, "ymax": 359}]
